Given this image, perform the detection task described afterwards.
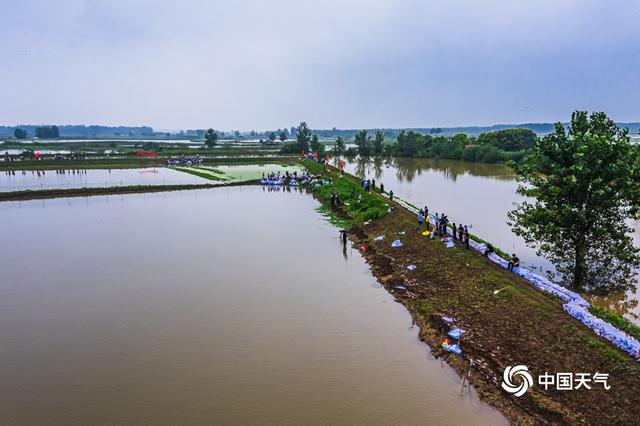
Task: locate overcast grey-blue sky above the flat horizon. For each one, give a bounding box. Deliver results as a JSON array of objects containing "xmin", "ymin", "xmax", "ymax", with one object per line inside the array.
[{"xmin": 0, "ymin": 0, "xmax": 640, "ymax": 130}]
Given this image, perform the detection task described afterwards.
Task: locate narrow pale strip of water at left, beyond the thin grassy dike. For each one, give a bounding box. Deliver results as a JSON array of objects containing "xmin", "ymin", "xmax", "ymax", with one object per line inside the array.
[{"xmin": 0, "ymin": 167, "xmax": 211, "ymax": 192}]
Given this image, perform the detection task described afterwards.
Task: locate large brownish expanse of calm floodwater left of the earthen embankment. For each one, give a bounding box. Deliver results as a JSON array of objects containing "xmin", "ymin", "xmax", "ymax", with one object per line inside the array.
[{"xmin": 0, "ymin": 187, "xmax": 506, "ymax": 425}]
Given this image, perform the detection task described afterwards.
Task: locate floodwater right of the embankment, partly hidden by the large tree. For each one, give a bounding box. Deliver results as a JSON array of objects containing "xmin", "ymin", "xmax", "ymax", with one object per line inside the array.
[{"xmin": 345, "ymin": 158, "xmax": 640, "ymax": 323}]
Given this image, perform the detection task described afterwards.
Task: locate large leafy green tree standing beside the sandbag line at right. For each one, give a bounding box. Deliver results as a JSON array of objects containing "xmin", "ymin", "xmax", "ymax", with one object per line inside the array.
[{"xmin": 509, "ymin": 111, "xmax": 640, "ymax": 292}]
